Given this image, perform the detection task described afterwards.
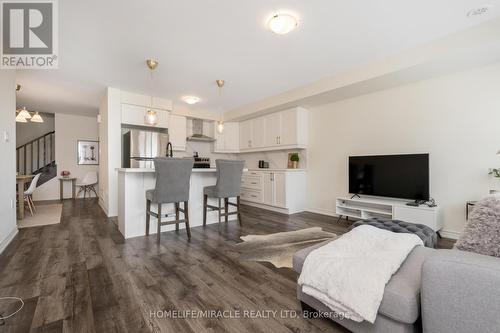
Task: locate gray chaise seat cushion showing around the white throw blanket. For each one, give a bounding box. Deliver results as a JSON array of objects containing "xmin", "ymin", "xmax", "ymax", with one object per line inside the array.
[{"xmin": 293, "ymin": 240, "xmax": 436, "ymax": 324}]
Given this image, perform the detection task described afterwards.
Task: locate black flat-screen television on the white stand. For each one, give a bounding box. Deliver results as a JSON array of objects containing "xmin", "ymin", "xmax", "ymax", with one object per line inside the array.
[{"xmin": 349, "ymin": 154, "xmax": 429, "ymax": 200}]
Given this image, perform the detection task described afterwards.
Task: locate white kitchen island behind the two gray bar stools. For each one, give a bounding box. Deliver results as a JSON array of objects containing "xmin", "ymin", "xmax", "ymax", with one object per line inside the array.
[{"xmin": 116, "ymin": 168, "xmax": 237, "ymax": 238}]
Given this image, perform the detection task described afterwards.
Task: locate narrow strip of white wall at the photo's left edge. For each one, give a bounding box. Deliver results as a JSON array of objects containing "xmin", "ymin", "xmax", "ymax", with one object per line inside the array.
[{"xmin": 0, "ymin": 70, "xmax": 17, "ymax": 253}]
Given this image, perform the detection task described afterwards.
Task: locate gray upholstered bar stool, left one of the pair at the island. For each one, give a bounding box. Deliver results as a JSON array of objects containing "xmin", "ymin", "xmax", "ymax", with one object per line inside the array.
[{"xmin": 146, "ymin": 158, "xmax": 194, "ymax": 243}]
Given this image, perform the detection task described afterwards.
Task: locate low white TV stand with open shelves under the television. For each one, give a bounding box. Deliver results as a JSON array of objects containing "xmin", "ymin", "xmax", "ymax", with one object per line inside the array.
[{"xmin": 335, "ymin": 196, "xmax": 442, "ymax": 232}]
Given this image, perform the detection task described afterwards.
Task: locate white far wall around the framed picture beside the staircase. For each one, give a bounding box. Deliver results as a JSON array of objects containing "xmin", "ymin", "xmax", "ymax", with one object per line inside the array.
[{"xmin": 33, "ymin": 113, "xmax": 99, "ymax": 201}]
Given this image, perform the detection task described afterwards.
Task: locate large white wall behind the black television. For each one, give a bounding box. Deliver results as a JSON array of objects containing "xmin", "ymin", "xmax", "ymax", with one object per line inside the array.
[{"xmin": 307, "ymin": 63, "xmax": 500, "ymax": 232}]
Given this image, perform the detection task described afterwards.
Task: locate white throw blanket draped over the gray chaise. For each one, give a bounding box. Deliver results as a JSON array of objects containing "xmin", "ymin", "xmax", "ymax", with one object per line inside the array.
[{"xmin": 298, "ymin": 225, "xmax": 423, "ymax": 323}]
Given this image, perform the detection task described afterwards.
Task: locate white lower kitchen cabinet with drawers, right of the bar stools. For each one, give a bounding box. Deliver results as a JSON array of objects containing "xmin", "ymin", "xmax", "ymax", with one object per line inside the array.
[{"xmin": 241, "ymin": 169, "xmax": 307, "ymax": 214}]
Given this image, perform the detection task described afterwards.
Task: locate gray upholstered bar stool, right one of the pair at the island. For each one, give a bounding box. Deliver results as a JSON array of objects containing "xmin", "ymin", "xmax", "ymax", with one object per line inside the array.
[{"xmin": 203, "ymin": 160, "xmax": 245, "ymax": 226}]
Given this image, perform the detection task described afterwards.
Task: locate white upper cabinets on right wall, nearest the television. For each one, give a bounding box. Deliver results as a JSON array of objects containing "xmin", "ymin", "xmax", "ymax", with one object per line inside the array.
[{"xmin": 240, "ymin": 107, "xmax": 308, "ymax": 152}]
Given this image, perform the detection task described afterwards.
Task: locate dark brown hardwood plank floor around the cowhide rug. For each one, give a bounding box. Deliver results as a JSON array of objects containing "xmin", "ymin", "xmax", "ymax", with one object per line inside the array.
[{"xmin": 0, "ymin": 199, "xmax": 452, "ymax": 333}]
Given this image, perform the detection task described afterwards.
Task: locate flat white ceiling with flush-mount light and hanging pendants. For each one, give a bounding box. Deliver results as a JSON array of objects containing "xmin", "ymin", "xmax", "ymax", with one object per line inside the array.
[{"xmin": 17, "ymin": 0, "xmax": 500, "ymax": 115}]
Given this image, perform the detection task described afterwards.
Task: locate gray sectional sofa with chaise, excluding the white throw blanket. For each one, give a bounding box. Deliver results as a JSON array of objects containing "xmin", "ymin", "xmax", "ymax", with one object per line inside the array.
[{"xmin": 293, "ymin": 243, "xmax": 500, "ymax": 333}]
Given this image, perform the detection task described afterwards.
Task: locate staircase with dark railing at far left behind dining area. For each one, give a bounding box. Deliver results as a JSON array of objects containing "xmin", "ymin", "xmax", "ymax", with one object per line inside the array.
[{"xmin": 16, "ymin": 131, "xmax": 57, "ymax": 186}]
